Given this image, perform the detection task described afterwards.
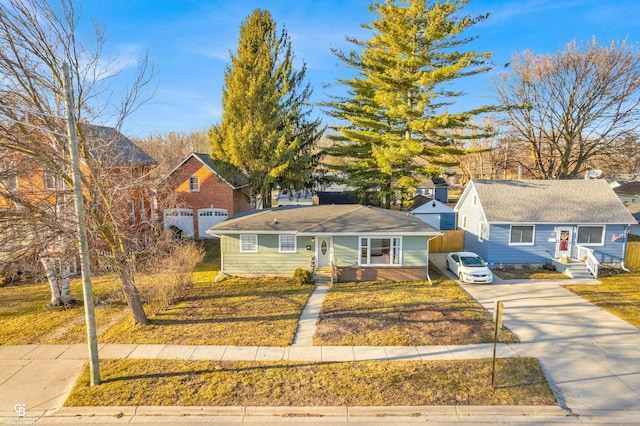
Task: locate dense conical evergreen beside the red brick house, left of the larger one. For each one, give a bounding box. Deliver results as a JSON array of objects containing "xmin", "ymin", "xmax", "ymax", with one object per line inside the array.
[{"xmin": 209, "ymin": 9, "xmax": 321, "ymax": 208}]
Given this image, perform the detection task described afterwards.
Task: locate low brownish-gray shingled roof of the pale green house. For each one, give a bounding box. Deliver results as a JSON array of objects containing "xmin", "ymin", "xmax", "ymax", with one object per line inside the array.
[{"xmin": 207, "ymin": 204, "xmax": 440, "ymax": 236}]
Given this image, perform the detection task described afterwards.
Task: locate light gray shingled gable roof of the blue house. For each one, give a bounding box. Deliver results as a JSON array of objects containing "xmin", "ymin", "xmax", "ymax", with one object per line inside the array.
[{"xmin": 456, "ymin": 179, "xmax": 636, "ymax": 224}]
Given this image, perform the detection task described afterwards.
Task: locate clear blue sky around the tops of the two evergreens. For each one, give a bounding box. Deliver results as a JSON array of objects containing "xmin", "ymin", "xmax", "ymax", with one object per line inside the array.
[{"xmin": 81, "ymin": 0, "xmax": 640, "ymax": 137}]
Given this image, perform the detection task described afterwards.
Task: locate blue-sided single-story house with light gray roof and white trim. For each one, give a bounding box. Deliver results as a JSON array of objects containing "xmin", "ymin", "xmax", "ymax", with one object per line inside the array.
[{"xmin": 454, "ymin": 179, "xmax": 637, "ymax": 265}]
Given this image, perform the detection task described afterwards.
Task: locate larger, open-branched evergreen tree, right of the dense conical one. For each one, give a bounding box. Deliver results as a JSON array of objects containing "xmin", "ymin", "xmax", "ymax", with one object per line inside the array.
[{"xmin": 323, "ymin": 0, "xmax": 491, "ymax": 208}]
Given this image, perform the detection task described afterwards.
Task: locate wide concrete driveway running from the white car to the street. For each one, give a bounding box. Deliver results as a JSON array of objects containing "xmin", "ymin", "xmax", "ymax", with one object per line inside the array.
[{"xmin": 462, "ymin": 280, "xmax": 640, "ymax": 413}]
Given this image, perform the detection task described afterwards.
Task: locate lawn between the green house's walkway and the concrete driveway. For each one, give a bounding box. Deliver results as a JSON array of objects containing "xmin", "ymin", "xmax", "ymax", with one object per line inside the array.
[{"xmin": 314, "ymin": 271, "xmax": 518, "ymax": 346}]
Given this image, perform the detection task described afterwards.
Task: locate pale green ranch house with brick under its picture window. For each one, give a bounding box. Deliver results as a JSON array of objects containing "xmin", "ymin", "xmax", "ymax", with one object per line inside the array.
[{"xmin": 207, "ymin": 205, "xmax": 441, "ymax": 281}]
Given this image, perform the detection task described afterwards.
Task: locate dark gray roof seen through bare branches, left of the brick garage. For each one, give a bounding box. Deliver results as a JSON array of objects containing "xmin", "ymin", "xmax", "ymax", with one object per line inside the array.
[{"xmin": 82, "ymin": 124, "xmax": 158, "ymax": 166}]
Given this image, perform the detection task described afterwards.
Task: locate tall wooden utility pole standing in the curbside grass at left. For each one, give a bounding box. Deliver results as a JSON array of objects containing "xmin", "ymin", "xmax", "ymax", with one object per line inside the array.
[{"xmin": 62, "ymin": 63, "xmax": 100, "ymax": 386}]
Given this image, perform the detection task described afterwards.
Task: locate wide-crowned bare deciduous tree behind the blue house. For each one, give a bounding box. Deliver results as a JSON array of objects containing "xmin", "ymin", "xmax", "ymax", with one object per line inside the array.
[{"xmin": 496, "ymin": 39, "xmax": 640, "ymax": 179}]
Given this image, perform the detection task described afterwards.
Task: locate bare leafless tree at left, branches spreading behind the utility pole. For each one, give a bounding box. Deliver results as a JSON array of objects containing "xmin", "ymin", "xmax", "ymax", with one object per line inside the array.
[{"xmin": 0, "ymin": 0, "xmax": 153, "ymax": 324}]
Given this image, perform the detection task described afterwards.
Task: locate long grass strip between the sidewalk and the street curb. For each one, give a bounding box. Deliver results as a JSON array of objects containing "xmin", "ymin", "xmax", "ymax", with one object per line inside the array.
[{"xmin": 65, "ymin": 358, "xmax": 556, "ymax": 406}]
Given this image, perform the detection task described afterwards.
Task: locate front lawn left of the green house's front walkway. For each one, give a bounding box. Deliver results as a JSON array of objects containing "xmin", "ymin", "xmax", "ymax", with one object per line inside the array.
[{"xmin": 99, "ymin": 280, "xmax": 313, "ymax": 346}]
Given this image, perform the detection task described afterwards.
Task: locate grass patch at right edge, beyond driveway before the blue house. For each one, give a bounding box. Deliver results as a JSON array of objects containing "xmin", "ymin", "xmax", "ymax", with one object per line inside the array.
[{"xmin": 565, "ymin": 272, "xmax": 640, "ymax": 327}]
